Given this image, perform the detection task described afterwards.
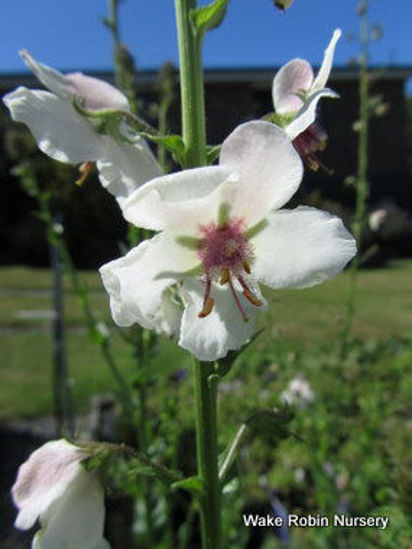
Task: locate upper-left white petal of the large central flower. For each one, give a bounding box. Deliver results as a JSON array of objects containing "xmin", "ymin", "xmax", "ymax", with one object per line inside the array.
[{"xmin": 122, "ymin": 166, "xmax": 232, "ymax": 235}]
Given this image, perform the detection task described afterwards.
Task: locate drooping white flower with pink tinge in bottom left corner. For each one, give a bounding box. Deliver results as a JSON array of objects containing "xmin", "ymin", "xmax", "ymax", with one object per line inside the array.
[{"xmin": 12, "ymin": 440, "xmax": 110, "ymax": 549}]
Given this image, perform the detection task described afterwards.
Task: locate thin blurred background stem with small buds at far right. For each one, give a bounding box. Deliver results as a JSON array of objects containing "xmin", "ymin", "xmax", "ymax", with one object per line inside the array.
[{"xmin": 341, "ymin": 0, "xmax": 369, "ymax": 358}]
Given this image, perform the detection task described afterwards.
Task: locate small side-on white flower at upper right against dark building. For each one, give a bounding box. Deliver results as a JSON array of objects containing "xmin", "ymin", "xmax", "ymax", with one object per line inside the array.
[{"xmin": 272, "ymin": 29, "xmax": 342, "ymax": 139}]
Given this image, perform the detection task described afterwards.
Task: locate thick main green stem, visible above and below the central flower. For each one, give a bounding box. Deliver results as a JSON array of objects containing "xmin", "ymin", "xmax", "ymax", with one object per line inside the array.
[{"xmin": 175, "ymin": 0, "xmax": 222, "ymax": 549}]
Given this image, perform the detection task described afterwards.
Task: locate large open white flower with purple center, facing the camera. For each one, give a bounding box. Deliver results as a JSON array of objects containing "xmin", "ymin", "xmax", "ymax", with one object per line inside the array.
[{"xmin": 100, "ymin": 121, "xmax": 356, "ymax": 361}]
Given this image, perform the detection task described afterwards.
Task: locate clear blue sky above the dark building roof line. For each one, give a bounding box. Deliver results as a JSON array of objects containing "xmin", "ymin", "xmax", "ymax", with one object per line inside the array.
[{"xmin": 0, "ymin": 0, "xmax": 412, "ymax": 85}]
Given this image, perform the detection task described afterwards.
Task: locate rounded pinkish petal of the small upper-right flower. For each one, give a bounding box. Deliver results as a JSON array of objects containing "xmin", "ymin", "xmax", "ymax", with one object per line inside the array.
[{"xmin": 272, "ymin": 59, "xmax": 313, "ymax": 114}]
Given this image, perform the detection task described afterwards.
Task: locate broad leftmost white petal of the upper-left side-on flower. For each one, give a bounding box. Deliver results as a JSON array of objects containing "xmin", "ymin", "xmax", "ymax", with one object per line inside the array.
[{"xmin": 3, "ymin": 87, "xmax": 102, "ymax": 164}]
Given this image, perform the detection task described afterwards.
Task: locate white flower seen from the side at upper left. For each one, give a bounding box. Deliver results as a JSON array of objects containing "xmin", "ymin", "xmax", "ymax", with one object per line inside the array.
[{"xmin": 3, "ymin": 50, "xmax": 161, "ymax": 204}]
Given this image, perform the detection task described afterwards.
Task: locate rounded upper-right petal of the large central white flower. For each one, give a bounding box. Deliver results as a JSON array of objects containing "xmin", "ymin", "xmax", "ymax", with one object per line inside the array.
[{"xmin": 220, "ymin": 121, "xmax": 303, "ymax": 227}]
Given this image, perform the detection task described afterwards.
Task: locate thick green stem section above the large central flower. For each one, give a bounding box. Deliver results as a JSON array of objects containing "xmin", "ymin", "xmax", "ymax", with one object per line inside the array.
[{"xmin": 175, "ymin": 0, "xmax": 206, "ymax": 168}]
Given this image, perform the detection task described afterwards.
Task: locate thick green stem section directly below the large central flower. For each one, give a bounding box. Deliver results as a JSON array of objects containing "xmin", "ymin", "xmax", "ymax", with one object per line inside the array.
[{"xmin": 193, "ymin": 359, "xmax": 222, "ymax": 549}]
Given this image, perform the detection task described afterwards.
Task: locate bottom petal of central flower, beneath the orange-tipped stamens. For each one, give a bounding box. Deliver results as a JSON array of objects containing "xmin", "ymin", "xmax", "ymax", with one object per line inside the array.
[{"xmin": 179, "ymin": 278, "xmax": 256, "ymax": 361}]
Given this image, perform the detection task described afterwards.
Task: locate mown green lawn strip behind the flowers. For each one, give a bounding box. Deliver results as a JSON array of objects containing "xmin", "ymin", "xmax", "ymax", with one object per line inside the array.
[{"xmin": 0, "ymin": 260, "xmax": 412, "ymax": 418}]
